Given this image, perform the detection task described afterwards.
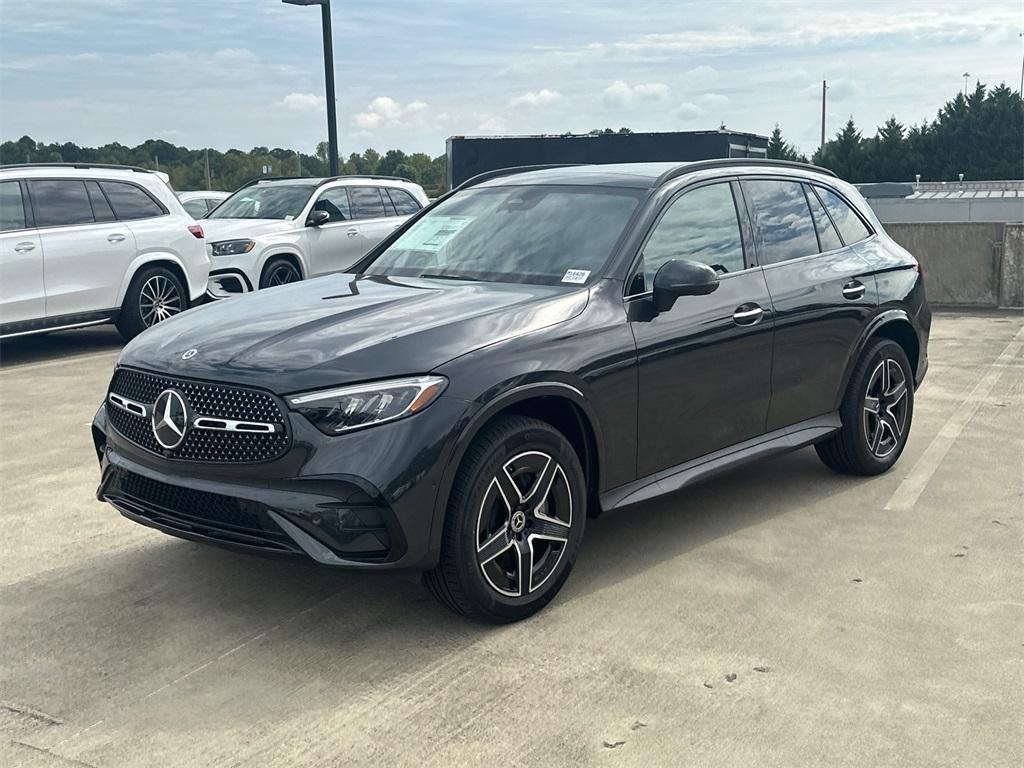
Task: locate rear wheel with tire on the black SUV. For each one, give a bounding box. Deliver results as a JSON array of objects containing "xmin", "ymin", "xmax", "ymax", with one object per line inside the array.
[{"xmin": 814, "ymin": 339, "xmax": 913, "ymax": 475}]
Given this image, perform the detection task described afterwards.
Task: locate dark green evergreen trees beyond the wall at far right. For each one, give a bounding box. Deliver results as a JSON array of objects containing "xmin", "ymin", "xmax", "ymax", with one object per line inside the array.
[{"xmin": 768, "ymin": 83, "xmax": 1024, "ymax": 183}]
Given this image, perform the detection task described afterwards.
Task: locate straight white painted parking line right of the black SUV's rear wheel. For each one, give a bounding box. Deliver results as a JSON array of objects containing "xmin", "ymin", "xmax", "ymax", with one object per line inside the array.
[{"xmin": 886, "ymin": 328, "xmax": 1024, "ymax": 512}]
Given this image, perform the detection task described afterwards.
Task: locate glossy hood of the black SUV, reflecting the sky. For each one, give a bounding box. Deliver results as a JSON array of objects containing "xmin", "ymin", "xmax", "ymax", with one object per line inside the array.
[{"xmin": 120, "ymin": 274, "xmax": 589, "ymax": 394}]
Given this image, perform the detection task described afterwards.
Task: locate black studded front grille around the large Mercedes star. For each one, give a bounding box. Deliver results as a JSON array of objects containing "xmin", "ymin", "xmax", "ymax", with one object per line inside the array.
[{"xmin": 106, "ymin": 368, "xmax": 289, "ymax": 464}]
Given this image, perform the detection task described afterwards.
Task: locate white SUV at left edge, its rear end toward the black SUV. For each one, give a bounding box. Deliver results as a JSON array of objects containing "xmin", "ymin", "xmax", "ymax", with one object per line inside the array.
[{"xmin": 0, "ymin": 163, "xmax": 210, "ymax": 339}]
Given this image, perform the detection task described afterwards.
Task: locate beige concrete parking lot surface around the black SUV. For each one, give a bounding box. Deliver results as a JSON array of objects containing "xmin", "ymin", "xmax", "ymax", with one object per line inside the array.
[{"xmin": 0, "ymin": 312, "xmax": 1024, "ymax": 768}]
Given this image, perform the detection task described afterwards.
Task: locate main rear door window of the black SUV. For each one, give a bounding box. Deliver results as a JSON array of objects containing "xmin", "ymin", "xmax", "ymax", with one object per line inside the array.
[{"xmin": 742, "ymin": 179, "xmax": 818, "ymax": 265}]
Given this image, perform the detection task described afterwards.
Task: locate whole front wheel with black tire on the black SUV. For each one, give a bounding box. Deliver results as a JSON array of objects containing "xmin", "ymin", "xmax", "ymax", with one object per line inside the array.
[{"xmin": 425, "ymin": 416, "xmax": 587, "ymax": 624}]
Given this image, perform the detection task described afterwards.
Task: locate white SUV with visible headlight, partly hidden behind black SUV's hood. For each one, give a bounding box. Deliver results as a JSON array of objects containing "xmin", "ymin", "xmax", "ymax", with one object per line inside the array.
[{"xmin": 203, "ymin": 176, "xmax": 427, "ymax": 299}]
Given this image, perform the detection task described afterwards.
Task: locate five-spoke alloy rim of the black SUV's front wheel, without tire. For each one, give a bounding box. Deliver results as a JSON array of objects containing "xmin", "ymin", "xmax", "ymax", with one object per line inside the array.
[{"xmin": 476, "ymin": 451, "xmax": 572, "ymax": 597}]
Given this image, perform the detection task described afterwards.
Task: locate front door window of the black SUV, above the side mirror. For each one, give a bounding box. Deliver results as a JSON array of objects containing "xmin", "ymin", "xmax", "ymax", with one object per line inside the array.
[{"xmin": 631, "ymin": 183, "xmax": 745, "ymax": 292}]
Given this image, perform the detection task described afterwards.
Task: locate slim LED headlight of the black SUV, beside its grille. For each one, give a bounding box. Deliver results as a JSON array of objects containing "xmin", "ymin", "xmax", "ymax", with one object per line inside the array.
[{"xmin": 288, "ymin": 376, "xmax": 447, "ymax": 435}]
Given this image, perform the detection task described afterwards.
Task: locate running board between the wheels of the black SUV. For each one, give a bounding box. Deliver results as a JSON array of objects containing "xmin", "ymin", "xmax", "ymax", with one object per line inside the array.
[{"xmin": 601, "ymin": 411, "xmax": 843, "ymax": 512}]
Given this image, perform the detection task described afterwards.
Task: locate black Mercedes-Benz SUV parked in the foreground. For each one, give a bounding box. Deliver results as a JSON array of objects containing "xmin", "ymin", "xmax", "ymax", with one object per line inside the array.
[{"xmin": 92, "ymin": 160, "xmax": 931, "ymax": 622}]
